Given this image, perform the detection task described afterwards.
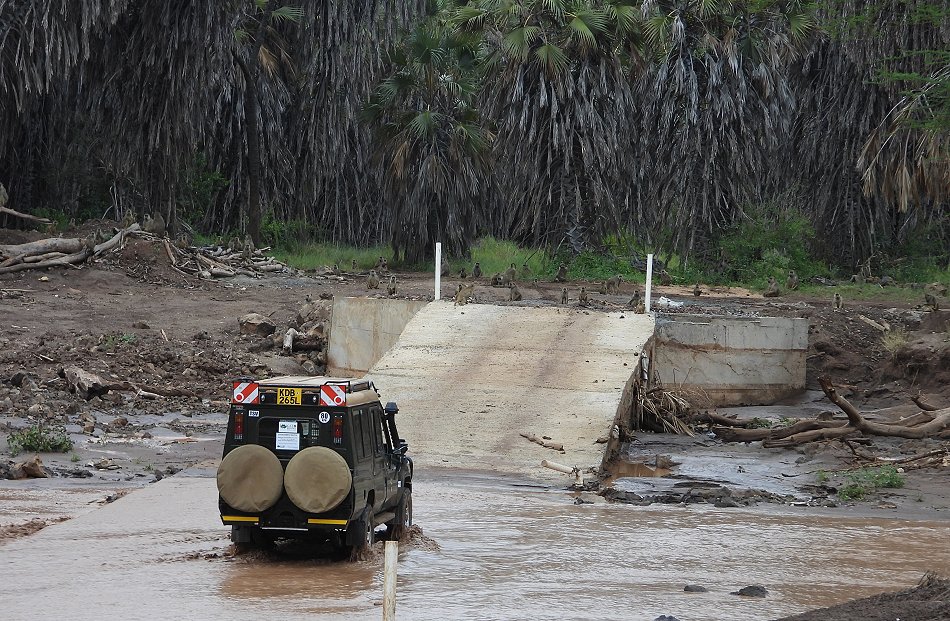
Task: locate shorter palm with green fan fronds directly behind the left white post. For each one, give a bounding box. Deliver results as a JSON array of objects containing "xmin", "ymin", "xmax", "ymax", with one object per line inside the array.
[{"xmin": 365, "ymin": 10, "xmax": 494, "ymax": 263}]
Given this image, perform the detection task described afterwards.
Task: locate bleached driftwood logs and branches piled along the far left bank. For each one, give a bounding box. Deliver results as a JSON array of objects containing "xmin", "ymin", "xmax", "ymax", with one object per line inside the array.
[{"xmin": 0, "ymin": 223, "xmax": 288, "ymax": 279}]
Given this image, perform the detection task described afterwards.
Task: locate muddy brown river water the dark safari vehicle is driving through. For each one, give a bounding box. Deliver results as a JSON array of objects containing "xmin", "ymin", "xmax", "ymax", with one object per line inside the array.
[{"xmin": 0, "ymin": 471, "xmax": 950, "ymax": 621}]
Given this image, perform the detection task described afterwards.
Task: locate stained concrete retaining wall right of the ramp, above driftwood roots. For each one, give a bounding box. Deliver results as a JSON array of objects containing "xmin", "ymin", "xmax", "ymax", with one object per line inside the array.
[{"xmin": 651, "ymin": 315, "xmax": 808, "ymax": 407}]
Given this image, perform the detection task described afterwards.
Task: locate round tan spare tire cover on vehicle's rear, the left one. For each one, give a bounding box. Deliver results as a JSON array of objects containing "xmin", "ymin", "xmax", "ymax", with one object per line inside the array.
[{"xmin": 218, "ymin": 444, "xmax": 284, "ymax": 513}]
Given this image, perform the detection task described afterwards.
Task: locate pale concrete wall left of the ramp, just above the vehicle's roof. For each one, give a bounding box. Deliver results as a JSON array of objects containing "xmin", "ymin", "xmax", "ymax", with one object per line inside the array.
[{"xmin": 327, "ymin": 298, "xmax": 427, "ymax": 377}]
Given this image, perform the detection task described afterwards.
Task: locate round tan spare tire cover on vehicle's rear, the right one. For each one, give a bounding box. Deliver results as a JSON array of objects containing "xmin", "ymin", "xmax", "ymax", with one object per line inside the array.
[{"xmin": 284, "ymin": 446, "xmax": 353, "ymax": 513}]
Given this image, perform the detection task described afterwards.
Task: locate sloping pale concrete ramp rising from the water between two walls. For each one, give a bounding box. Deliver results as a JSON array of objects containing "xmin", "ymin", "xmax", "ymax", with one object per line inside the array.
[{"xmin": 367, "ymin": 301, "xmax": 654, "ymax": 480}]
